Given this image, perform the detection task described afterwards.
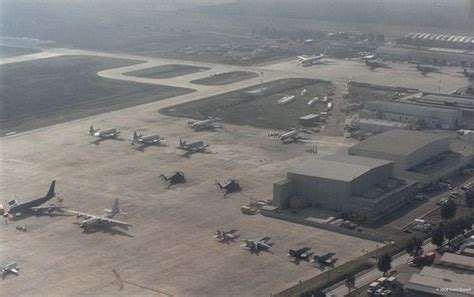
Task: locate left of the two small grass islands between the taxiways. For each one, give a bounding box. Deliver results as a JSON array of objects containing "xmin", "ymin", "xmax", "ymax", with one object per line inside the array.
[{"xmin": 125, "ymin": 64, "xmax": 210, "ymax": 78}]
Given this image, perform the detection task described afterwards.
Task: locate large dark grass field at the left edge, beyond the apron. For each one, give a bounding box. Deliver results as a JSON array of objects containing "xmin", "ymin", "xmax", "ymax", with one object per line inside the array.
[{"xmin": 0, "ymin": 56, "xmax": 193, "ymax": 135}]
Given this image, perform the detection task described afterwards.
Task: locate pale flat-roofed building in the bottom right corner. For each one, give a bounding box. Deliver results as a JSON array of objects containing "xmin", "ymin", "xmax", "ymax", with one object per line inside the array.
[{"xmin": 405, "ymin": 267, "xmax": 473, "ymax": 296}]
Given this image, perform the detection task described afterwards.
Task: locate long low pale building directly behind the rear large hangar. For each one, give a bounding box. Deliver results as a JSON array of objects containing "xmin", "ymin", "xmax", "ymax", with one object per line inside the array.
[{"xmin": 359, "ymin": 101, "xmax": 462, "ymax": 130}]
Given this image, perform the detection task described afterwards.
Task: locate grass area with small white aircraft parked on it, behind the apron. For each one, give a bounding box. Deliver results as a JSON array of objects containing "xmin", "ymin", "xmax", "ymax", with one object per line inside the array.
[{"xmin": 160, "ymin": 79, "xmax": 333, "ymax": 129}]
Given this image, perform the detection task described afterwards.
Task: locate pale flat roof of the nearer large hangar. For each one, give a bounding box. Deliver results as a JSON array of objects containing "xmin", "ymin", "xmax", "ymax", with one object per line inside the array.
[{"xmin": 288, "ymin": 154, "xmax": 392, "ymax": 182}]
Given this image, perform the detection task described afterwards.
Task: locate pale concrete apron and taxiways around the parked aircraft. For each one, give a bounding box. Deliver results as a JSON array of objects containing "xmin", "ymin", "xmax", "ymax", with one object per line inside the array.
[{"xmin": 0, "ymin": 45, "xmax": 470, "ymax": 296}]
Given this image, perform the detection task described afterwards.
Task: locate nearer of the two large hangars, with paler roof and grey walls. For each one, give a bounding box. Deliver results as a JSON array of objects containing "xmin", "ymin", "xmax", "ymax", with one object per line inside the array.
[{"xmin": 273, "ymin": 154, "xmax": 417, "ymax": 219}]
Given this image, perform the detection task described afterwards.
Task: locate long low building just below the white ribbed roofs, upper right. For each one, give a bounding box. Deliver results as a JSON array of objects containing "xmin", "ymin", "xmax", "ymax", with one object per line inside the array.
[{"xmin": 375, "ymin": 46, "xmax": 474, "ymax": 68}]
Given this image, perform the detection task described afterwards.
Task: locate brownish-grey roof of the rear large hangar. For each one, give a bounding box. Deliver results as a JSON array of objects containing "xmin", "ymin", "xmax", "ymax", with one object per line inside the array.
[{"xmin": 349, "ymin": 129, "xmax": 449, "ymax": 156}]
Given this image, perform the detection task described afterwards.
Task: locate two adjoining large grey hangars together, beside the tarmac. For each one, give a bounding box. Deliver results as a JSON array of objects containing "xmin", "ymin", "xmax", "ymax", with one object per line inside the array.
[{"xmin": 273, "ymin": 130, "xmax": 473, "ymax": 220}]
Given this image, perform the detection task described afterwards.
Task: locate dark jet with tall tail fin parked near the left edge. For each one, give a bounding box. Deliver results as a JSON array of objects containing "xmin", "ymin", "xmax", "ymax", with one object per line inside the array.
[{"xmin": 8, "ymin": 180, "xmax": 64, "ymax": 217}]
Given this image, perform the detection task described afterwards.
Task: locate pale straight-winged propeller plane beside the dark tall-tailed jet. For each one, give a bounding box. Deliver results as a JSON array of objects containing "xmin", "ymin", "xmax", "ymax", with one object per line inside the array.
[{"xmin": 68, "ymin": 199, "xmax": 132, "ymax": 232}]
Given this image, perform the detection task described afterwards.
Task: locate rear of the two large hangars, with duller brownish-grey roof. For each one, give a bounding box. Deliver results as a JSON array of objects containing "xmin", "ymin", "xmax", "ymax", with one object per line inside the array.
[{"xmin": 349, "ymin": 129, "xmax": 450, "ymax": 175}]
